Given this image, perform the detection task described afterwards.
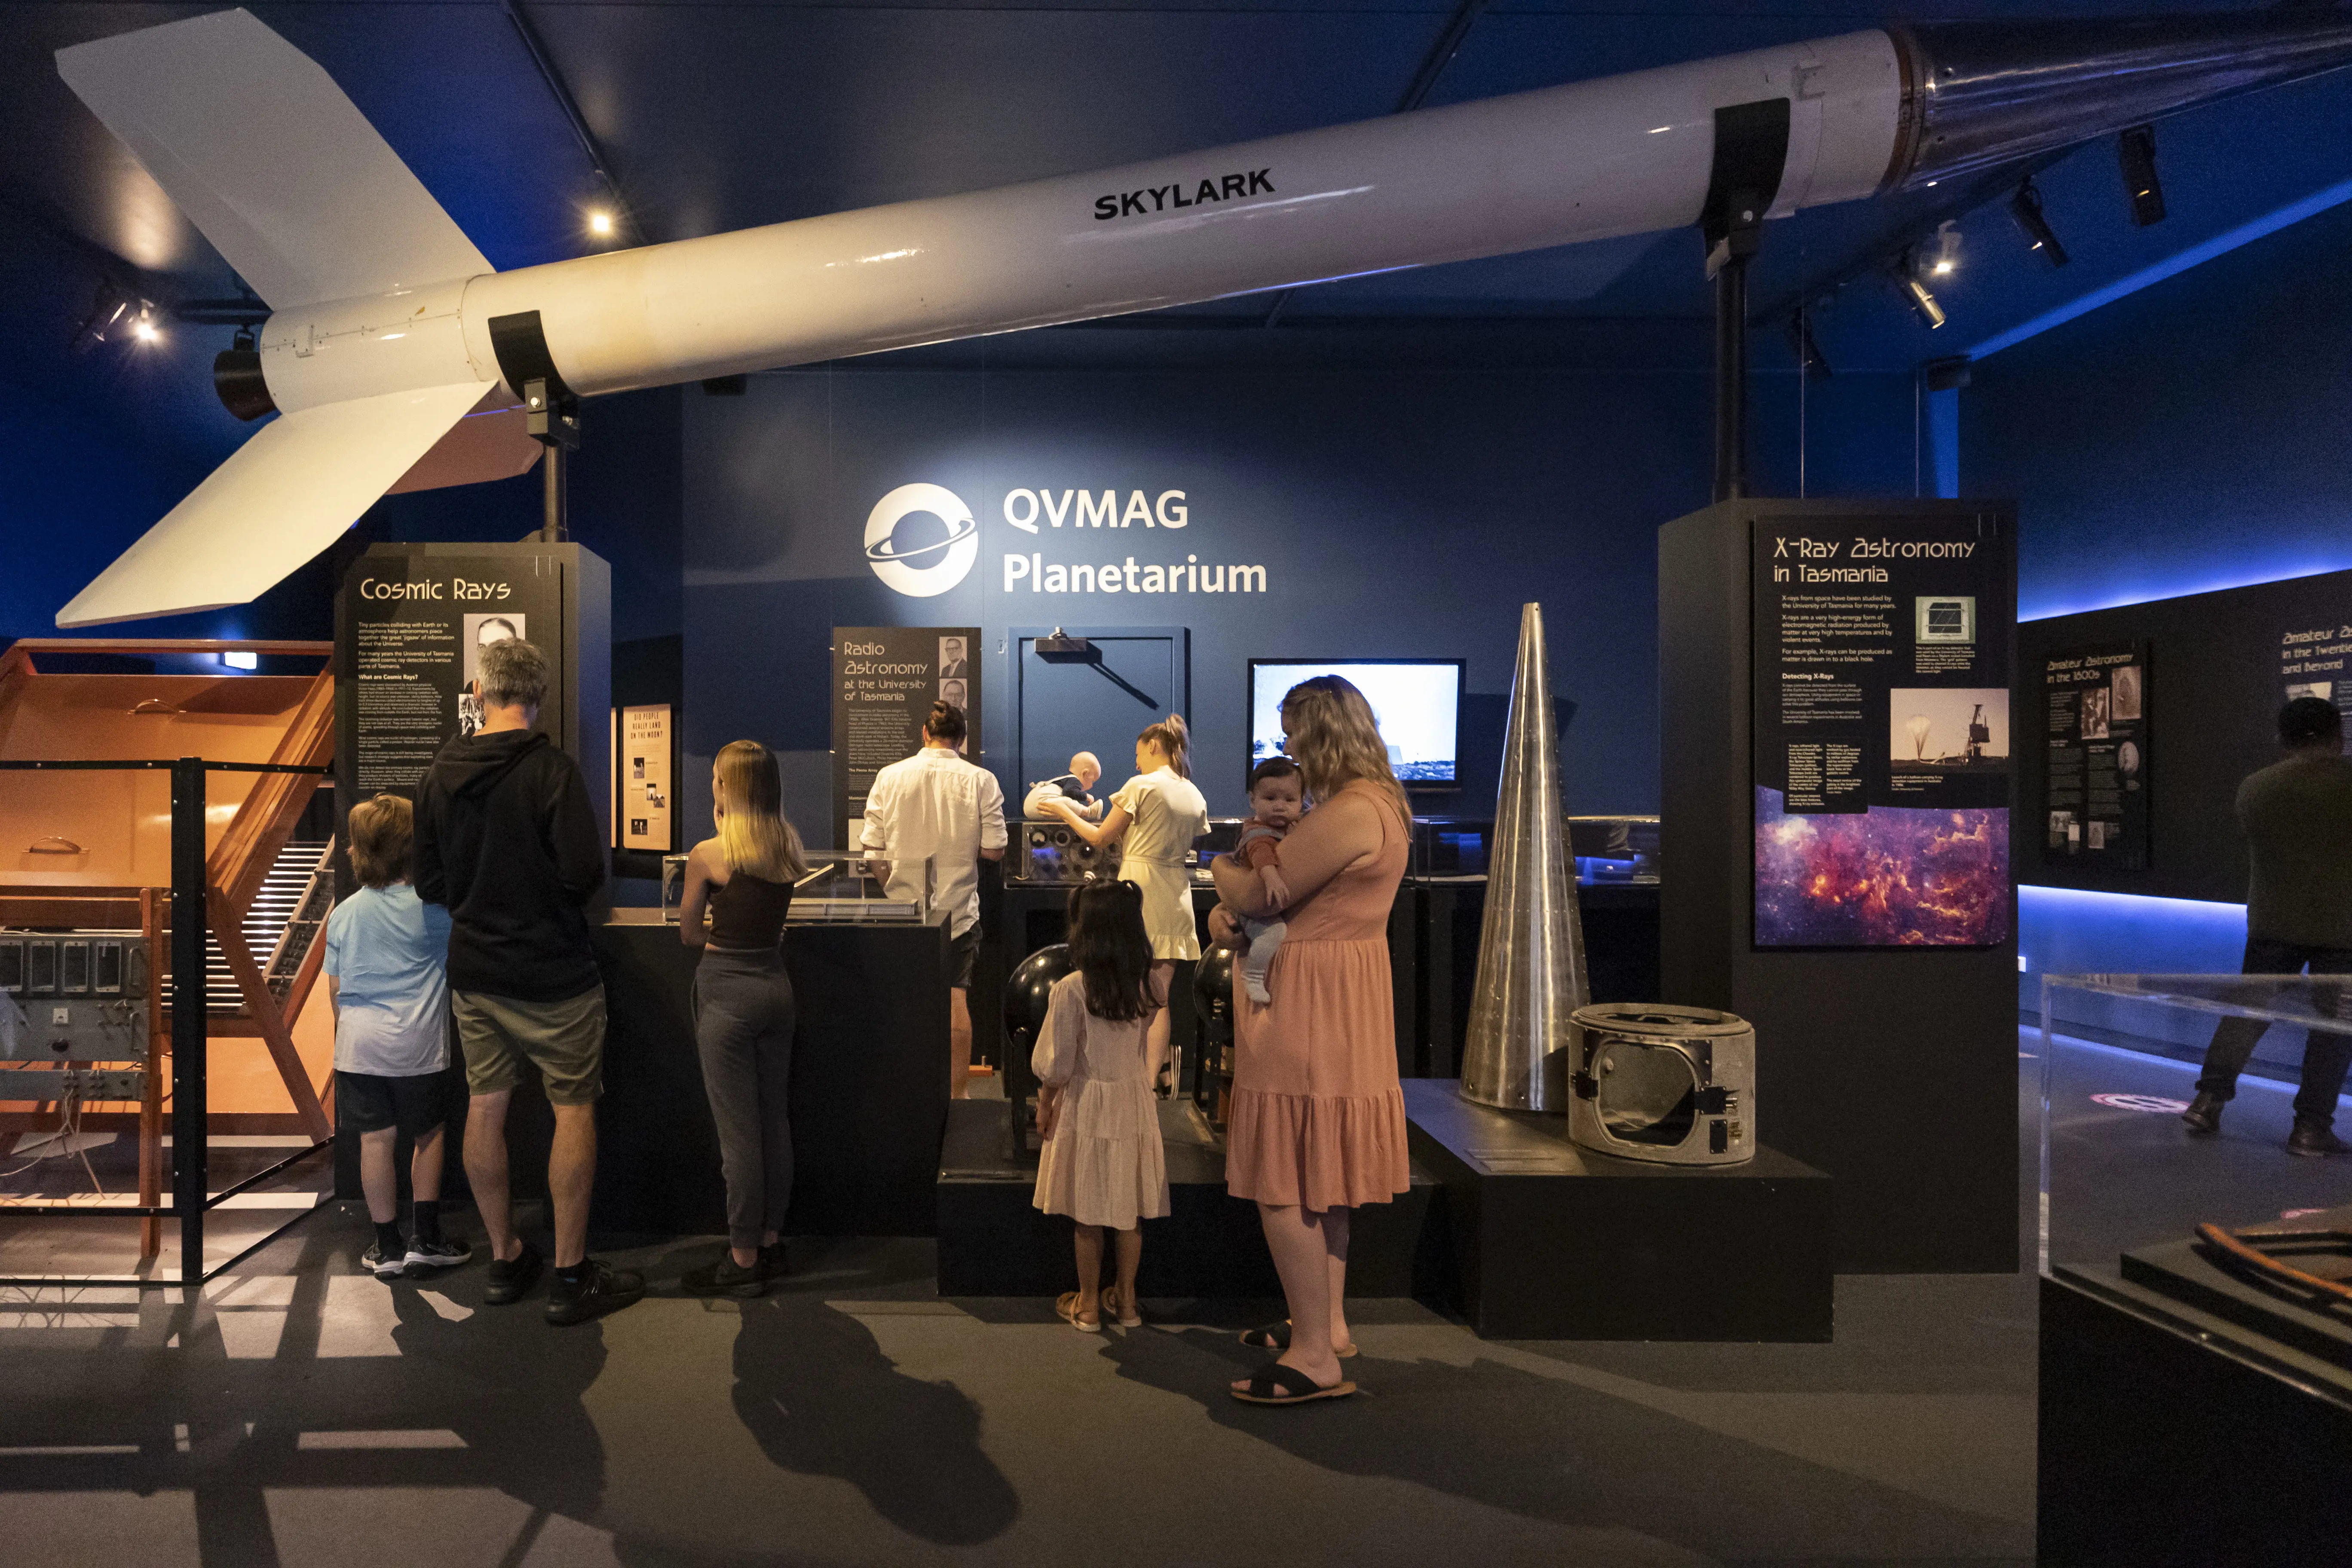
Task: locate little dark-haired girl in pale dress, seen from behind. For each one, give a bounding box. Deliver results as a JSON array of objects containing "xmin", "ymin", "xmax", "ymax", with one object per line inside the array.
[{"xmin": 1030, "ymin": 882, "xmax": 1169, "ymax": 1333}]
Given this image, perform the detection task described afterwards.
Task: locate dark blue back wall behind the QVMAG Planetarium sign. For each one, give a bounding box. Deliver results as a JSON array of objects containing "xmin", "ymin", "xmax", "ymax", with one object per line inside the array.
[{"xmin": 677, "ymin": 362, "xmax": 1910, "ymax": 835}]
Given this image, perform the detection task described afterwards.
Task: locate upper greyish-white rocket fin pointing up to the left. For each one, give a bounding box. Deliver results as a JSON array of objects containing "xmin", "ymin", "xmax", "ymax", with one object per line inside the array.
[{"xmin": 56, "ymin": 9, "xmax": 494, "ymax": 308}]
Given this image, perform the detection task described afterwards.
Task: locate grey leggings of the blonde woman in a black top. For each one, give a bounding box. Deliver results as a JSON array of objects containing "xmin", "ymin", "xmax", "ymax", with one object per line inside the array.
[{"xmin": 694, "ymin": 947, "xmax": 793, "ymax": 1251}]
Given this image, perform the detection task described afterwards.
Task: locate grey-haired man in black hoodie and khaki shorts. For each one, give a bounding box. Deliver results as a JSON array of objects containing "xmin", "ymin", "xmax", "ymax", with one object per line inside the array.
[{"xmin": 416, "ymin": 637, "xmax": 644, "ymax": 1323}]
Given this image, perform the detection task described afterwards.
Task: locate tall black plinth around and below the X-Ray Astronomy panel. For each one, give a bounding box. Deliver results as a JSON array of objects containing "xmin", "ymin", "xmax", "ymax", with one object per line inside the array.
[{"xmin": 1656, "ymin": 498, "xmax": 2039, "ymax": 1274}]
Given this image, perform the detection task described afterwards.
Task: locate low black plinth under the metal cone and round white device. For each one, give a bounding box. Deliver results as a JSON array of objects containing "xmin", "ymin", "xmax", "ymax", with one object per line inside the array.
[{"xmin": 1404, "ymin": 1079, "xmax": 1834, "ymax": 1342}]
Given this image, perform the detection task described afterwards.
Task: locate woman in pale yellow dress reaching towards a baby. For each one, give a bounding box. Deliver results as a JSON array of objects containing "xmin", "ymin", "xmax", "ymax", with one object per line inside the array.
[{"xmin": 1037, "ymin": 712, "xmax": 1209, "ymax": 1084}]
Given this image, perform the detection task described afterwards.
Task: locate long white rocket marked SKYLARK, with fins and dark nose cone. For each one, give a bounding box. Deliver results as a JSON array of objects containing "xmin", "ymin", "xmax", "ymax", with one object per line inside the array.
[{"xmin": 56, "ymin": 9, "xmax": 2352, "ymax": 628}]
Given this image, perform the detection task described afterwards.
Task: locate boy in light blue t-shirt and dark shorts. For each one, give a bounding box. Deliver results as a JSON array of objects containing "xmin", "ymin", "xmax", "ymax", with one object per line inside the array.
[{"xmin": 327, "ymin": 795, "xmax": 473, "ymax": 1279}]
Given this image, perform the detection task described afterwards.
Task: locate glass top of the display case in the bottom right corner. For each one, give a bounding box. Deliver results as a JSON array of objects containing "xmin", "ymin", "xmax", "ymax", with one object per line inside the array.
[{"xmin": 2039, "ymin": 976, "xmax": 2352, "ymax": 1399}]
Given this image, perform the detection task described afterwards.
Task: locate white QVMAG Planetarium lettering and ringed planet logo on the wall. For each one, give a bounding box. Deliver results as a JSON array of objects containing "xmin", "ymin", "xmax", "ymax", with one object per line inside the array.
[{"xmin": 866, "ymin": 484, "xmax": 1268, "ymax": 600}]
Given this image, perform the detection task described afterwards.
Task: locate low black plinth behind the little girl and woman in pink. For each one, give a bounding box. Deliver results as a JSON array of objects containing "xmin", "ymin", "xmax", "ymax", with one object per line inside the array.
[{"xmin": 936, "ymin": 1100, "xmax": 1446, "ymax": 1298}]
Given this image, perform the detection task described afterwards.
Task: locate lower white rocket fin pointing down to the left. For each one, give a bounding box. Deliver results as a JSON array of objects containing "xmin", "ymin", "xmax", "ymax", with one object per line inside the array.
[{"xmin": 56, "ymin": 381, "xmax": 482, "ymax": 628}]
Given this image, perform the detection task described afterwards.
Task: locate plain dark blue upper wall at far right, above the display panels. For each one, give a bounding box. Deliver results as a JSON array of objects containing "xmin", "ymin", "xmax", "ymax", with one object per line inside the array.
[{"xmin": 1962, "ymin": 190, "xmax": 2352, "ymax": 618}]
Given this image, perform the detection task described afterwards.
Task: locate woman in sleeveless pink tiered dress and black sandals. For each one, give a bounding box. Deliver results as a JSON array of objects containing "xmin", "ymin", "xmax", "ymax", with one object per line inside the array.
[{"xmin": 1214, "ymin": 675, "xmax": 1411, "ymax": 1403}]
